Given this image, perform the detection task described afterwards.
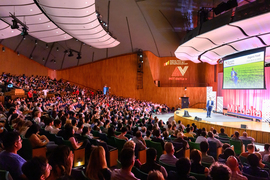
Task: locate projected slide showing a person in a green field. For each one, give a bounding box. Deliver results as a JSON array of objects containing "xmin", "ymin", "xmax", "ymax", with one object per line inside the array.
[{"xmin": 223, "ymin": 50, "xmax": 265, "ymax": 89}]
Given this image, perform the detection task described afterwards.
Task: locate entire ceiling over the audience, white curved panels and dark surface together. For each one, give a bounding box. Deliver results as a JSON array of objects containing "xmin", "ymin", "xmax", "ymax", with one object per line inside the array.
[{"xmin": 0, "ymin": 0, "xmax": 253, "ymax": 69}]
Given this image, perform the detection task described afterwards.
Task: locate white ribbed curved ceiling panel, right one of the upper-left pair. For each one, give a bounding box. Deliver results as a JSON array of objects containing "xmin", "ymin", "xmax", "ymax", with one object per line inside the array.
[{"xmin": 37, "ymin": 0, "xmax": 120, "ymax": 48}]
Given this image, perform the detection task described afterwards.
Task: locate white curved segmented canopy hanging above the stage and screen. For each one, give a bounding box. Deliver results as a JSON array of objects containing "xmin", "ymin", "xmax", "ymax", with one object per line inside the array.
[{"xmin": 175, "ymin": 2, "xmax": 270, "ymax": 64}]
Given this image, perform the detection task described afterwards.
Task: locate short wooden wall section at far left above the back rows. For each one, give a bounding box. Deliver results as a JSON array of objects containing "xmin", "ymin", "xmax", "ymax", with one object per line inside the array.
[{"xmin": 0, "ymin": 45, "xmax": 49, "ymax": 76}]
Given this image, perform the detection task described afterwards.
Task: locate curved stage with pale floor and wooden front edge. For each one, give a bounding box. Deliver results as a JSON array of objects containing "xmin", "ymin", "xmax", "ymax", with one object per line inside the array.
[{"xmin": 174, "ymin": 108, "xmax": 270, "ymax": 143}]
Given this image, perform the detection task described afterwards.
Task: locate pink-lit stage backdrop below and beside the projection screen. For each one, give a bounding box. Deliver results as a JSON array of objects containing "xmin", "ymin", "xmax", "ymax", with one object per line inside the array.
[{"xmin": 218, "ymin": 67, "xmax": 270, "ymax": 116}]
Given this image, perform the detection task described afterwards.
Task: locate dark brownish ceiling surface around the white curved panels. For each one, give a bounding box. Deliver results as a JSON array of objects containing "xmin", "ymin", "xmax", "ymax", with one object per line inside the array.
[{"xmin": 0, "ymin": 0, "xmax": 250, "ymax": 69}]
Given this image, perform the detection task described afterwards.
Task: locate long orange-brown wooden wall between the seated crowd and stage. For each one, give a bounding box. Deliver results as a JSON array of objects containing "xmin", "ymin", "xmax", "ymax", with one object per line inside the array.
[{"xmin": 56, "ymin": 52, "xmax": 209, "ymax": 107}]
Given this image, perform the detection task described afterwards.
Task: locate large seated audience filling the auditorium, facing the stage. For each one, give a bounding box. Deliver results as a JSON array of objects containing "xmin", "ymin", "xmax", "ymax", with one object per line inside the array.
[{"xmin": 0, "ymin": 73, "xmax": 270, "ymax": 180}]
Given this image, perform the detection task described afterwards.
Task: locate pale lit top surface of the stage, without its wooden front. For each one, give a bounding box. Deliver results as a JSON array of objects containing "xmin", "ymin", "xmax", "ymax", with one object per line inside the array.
[{"xmin": 175, "ymin": 108, "xmax": 270, "ymax": 132}]
